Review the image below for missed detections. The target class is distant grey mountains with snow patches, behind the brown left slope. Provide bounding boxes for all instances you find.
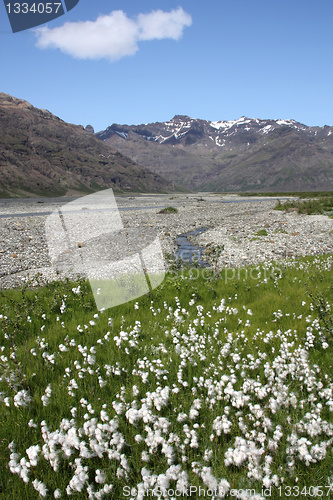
[96,115,333,192]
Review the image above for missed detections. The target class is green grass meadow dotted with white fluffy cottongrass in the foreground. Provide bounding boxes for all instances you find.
[0,256,333,500]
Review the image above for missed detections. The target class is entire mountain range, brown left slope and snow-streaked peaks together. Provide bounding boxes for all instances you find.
[0,93,333,197]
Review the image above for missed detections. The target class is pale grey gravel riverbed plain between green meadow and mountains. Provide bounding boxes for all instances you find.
[0,193,333,288]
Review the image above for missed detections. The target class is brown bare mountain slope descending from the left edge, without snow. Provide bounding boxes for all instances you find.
[0,93,174,197]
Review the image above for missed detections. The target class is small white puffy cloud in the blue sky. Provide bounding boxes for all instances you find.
[35,7,192,61]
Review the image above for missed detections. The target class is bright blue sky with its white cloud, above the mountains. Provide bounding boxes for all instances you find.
[0,0,333,131]
